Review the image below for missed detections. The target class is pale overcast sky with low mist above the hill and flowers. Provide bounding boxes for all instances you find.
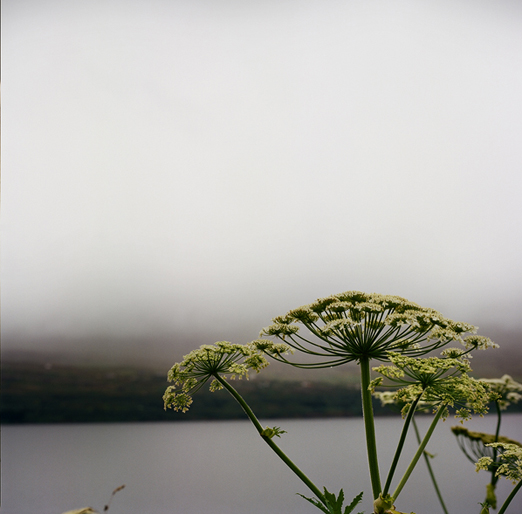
[1,0,522,364]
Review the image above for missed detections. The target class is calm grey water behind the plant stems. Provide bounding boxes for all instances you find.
[1,414,522,514]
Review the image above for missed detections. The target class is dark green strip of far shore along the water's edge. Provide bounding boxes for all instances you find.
[5,361,522,424]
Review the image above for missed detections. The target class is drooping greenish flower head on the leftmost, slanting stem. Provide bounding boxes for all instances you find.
[163,341,268,412]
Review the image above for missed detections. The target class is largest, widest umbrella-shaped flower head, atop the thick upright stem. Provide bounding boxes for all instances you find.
[261,291,495,368]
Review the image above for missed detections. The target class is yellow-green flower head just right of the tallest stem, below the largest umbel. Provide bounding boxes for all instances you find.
[372,352,491,419]
